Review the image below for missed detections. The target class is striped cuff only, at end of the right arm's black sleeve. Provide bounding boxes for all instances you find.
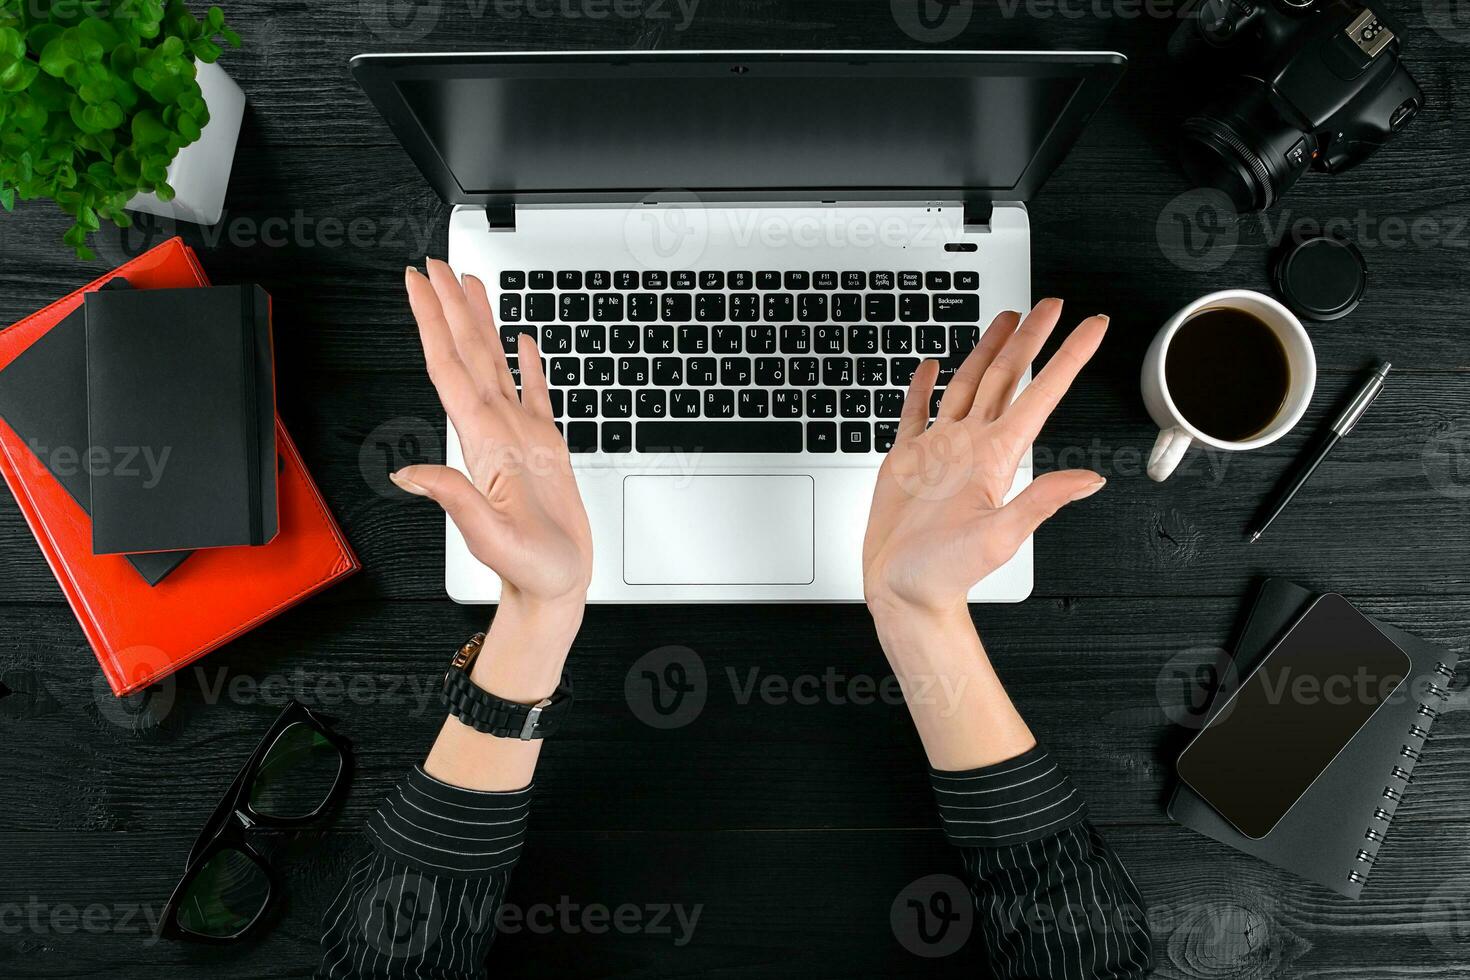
[929,745,1088,848]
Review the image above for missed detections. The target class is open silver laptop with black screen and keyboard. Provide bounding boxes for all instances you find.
[351,50,1125,602]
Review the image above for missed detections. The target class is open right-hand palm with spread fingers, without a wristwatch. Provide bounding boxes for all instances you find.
[863,300,1108,619]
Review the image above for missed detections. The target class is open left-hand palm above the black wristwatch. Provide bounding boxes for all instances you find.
[392,259,592,633]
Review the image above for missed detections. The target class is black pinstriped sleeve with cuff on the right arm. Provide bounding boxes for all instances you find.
[931,746,1154,980]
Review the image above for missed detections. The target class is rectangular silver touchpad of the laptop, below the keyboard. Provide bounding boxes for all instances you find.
[623,475,816,585]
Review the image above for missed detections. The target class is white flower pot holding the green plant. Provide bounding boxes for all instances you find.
[128,62,245,225]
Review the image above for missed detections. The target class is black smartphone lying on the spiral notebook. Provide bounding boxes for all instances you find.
[1177,594,1413,840]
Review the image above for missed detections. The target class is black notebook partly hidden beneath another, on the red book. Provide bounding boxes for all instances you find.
[0,278,190,585]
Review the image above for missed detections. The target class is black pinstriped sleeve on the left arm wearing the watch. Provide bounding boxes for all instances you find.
[316,767,531,980]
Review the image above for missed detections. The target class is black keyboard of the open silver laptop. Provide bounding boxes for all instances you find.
[497,269,980,453]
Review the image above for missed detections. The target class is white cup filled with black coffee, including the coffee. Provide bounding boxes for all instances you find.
[1142,289,1317,482]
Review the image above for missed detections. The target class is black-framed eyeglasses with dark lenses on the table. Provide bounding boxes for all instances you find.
[159,701,351,943]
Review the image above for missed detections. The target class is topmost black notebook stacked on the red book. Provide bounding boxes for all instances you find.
[87,287,276,554]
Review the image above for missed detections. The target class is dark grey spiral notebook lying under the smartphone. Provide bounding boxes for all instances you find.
[1169,579,1457,898]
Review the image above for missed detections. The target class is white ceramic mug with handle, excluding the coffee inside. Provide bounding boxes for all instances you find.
[1144,289,1317,482]
